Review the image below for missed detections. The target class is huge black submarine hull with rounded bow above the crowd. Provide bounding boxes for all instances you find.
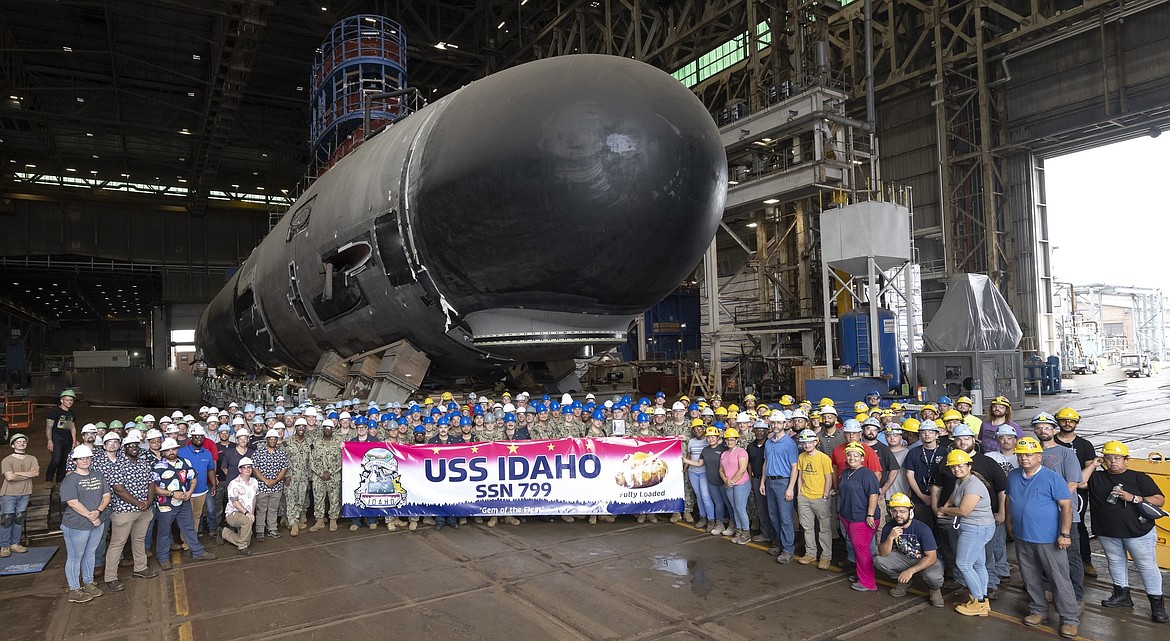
[195,54,728,388]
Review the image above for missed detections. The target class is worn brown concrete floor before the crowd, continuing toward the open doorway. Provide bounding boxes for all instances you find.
[0,370,1170,641]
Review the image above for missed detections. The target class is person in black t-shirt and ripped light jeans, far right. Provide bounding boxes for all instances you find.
[1088,441,1168,623]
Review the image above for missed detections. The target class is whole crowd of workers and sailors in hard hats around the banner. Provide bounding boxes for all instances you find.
[0,390,1166,637]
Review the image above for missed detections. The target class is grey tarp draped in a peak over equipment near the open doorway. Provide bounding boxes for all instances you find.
[923,274,1024,352]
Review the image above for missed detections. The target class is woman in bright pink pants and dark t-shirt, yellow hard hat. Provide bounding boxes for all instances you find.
[837,443,879,592]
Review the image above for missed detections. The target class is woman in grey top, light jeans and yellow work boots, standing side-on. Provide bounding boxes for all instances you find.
[937,449,996,616]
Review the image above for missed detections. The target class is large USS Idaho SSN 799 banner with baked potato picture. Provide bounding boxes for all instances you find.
[342,439,684,517]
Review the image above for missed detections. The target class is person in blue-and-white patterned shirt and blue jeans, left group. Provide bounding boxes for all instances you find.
[151,439,215,570]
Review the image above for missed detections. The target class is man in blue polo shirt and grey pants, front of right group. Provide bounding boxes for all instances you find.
[1005,436,1080,639]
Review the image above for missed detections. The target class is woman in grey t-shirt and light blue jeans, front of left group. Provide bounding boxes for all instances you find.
[61,446,110,604]
